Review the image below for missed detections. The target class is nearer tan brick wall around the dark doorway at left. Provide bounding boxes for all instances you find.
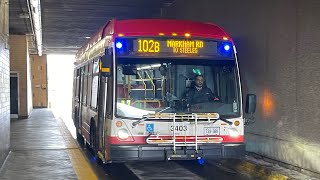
[9,35,32,118]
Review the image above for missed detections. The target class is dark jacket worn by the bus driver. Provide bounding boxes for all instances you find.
[186,87,214,104]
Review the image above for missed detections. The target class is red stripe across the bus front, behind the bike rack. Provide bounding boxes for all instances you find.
[106,135,244,144]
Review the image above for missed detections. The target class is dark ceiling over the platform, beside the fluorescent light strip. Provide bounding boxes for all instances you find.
[9,0,174,53]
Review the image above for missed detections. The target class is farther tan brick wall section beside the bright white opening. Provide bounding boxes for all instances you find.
[31,54,48,107]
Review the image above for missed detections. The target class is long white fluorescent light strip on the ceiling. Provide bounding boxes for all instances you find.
[29,0,42,56]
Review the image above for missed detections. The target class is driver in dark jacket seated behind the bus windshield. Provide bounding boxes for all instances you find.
[186,75,220,105]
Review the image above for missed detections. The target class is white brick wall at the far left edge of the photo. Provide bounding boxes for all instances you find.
[0,0,10,167]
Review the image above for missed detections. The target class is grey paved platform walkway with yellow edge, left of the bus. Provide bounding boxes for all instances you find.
[0,109,97,180]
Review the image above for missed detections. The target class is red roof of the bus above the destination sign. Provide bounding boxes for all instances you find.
[76,19,232,62]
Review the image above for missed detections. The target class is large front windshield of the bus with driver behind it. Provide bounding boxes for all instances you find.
[116,58,240,118]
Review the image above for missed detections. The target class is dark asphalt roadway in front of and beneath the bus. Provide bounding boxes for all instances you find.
[83,149,250,180]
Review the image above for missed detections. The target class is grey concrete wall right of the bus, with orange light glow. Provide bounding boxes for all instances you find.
[163,0,320,173]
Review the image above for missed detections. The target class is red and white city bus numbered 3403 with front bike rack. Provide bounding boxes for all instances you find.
[73,19,256,163]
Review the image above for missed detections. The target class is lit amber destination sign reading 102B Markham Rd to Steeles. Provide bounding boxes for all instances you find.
[132,38,217,56]
